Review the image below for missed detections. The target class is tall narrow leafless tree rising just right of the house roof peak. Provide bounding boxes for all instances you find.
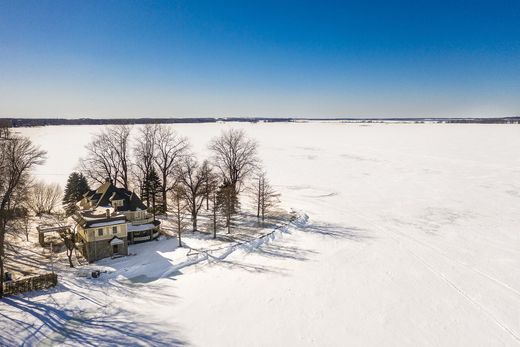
[133,124,158,207]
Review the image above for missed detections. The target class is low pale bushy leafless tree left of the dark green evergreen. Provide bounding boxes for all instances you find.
[29,181,63,216]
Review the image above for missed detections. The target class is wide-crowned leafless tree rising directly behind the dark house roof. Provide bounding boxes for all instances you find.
[80,125,131,189]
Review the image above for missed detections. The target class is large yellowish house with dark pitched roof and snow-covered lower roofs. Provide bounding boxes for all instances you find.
[73,180,160,262]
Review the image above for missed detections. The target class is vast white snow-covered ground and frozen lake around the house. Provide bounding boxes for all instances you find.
[0,123,520,346]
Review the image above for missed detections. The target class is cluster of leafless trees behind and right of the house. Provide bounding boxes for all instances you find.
[77,124,277,239]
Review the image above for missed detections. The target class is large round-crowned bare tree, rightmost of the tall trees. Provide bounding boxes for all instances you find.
[209,129,258,206]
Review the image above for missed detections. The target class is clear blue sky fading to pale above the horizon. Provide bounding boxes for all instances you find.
[0,0,520,117]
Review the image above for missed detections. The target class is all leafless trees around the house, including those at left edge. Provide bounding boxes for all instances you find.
[0,124,279,297]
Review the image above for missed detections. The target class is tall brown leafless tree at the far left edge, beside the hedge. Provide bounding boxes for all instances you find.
[0,134,46,297]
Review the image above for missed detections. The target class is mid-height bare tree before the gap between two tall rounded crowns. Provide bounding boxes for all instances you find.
[179,156,209,231]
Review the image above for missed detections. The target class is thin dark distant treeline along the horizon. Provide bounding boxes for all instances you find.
[0,117,520,128]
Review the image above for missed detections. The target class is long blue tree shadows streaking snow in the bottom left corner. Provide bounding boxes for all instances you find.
[0,297,187,346]
